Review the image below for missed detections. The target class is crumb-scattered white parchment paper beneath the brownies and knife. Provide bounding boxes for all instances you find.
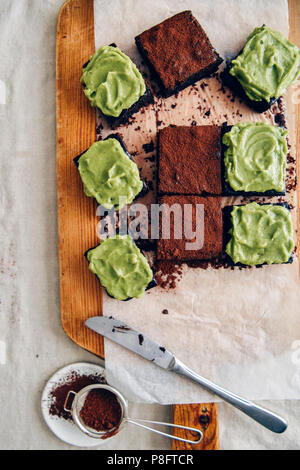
[95,0,300,404]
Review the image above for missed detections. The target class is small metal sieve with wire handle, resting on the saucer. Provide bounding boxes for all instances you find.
[64,384,203,445]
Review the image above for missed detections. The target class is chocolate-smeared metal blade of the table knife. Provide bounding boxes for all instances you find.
[85,317,175,370]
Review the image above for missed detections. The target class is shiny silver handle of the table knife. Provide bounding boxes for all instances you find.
[170,358,287,433]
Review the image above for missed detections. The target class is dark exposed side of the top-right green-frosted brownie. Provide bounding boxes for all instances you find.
[220,57,279,113]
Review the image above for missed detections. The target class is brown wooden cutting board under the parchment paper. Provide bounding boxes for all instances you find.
[56,0,300,450]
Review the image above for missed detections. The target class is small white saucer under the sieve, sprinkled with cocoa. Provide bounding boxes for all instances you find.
[41,362,105,447]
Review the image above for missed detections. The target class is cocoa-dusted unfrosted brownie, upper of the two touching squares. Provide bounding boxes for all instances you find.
[158,125,222,195]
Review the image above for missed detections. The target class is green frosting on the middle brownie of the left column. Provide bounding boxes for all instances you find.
[78,138,143,210]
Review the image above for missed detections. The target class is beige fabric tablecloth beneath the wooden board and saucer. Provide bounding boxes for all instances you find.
[0,0,300,450]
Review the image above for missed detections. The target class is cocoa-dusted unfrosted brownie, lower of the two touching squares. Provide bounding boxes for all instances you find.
[157,196,223,262]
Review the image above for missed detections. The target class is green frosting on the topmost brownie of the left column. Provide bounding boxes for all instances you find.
[81,46,146,117]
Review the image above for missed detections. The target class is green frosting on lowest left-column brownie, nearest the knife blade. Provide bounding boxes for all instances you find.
[87,235,153,300]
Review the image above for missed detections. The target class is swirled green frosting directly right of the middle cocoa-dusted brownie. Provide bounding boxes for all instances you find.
[222,122,288,193]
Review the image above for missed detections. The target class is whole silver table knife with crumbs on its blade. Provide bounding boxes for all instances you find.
[85,317,287,433]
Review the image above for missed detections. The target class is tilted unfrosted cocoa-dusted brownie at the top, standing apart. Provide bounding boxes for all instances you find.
[135,10,223,97]
